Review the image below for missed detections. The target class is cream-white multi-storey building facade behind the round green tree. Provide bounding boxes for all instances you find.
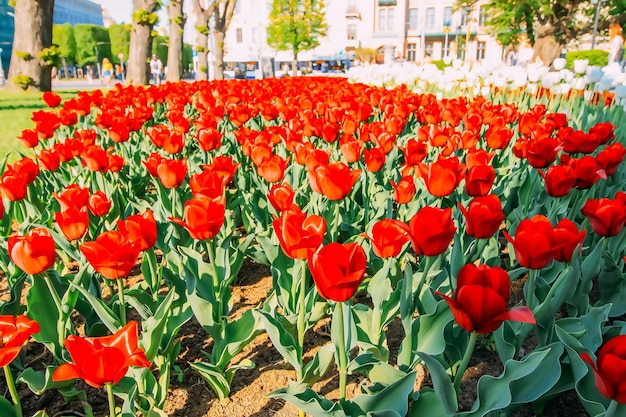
[201,0,503,69]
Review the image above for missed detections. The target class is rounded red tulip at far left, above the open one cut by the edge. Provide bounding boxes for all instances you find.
[9,227,57,275]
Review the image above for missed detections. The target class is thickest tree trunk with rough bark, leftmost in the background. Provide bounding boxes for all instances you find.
[8,0,54,91]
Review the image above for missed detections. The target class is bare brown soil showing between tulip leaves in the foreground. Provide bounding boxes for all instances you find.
[0,261,587,417]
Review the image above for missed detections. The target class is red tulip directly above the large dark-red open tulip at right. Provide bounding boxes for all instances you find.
[459,194,505,239]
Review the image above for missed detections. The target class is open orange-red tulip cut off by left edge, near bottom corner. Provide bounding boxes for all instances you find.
[0,315,39,367]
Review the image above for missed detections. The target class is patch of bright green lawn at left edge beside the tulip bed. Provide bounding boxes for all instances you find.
[0,90,76,161]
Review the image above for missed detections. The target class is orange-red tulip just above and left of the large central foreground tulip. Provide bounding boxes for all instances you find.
[272,209,326,259]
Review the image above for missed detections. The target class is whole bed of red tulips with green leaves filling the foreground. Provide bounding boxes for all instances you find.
[0,78,626,416]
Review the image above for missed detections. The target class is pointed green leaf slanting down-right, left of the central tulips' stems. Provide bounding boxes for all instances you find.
[254,309,302,371]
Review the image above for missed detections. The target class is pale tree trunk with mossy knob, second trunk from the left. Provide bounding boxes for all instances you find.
[127,0,159,85]
